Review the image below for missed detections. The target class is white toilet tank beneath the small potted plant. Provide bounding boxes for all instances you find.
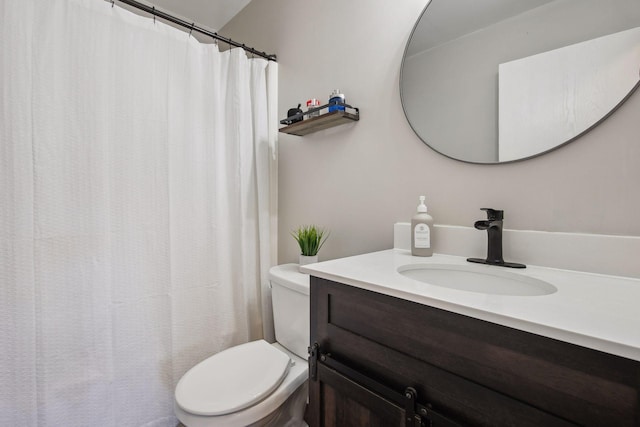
[269,264,310,359]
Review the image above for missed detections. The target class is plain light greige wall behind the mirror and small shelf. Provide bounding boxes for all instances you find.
[220,0,640,263]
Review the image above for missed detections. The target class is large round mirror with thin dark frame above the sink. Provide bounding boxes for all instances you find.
[400,0,640,163]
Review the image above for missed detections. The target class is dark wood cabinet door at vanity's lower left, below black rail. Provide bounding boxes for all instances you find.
[308,363,405,427]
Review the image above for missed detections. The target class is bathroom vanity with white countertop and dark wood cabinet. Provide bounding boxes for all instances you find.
[306,250,640,427]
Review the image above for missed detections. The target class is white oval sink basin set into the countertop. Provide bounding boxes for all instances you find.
[398,264,558,296]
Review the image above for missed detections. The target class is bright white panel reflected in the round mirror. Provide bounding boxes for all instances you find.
[498,27,640,162]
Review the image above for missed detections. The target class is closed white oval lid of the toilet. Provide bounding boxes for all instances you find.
[176,340,291,415]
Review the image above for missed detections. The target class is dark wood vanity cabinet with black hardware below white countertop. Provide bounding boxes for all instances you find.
[308,277,640,427]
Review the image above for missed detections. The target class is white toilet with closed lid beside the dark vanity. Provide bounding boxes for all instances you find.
[174,264,309,427]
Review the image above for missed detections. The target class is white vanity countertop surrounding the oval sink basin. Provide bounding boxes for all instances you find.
[301,249,640,361]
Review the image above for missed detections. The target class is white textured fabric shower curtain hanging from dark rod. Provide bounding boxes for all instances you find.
[0,0,277,427]
